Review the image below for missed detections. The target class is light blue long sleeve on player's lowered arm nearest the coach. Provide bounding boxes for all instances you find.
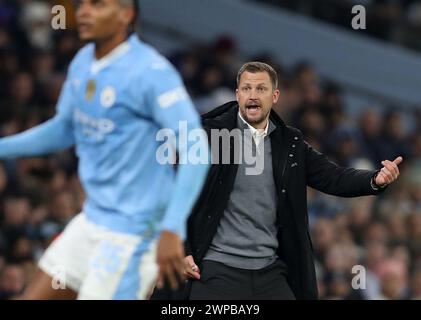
[147,62,209,238]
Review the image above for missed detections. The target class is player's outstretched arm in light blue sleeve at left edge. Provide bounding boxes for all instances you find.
[0,80,74,159]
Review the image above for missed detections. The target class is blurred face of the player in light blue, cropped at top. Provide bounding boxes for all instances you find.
[76,0,133,41]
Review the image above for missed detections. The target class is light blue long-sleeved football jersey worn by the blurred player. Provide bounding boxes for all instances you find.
[0,35,208,238]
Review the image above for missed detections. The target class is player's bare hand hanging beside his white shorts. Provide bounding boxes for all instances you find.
[156,231,185,290]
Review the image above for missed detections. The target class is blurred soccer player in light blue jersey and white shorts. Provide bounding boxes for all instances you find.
[0,0,207,299]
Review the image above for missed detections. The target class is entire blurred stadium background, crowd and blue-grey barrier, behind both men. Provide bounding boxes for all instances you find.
[0,0,421,299]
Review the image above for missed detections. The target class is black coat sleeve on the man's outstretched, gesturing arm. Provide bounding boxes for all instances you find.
[304,142,385,197]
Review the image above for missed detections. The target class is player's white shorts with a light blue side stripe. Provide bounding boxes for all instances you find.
[39,213,158,300]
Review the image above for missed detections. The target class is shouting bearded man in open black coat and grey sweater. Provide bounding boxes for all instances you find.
[181,62,402,299]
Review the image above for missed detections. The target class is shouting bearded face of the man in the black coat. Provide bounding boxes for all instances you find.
[235,71,279,128]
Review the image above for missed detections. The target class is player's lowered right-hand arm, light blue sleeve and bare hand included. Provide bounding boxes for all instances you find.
[145,63,209,288]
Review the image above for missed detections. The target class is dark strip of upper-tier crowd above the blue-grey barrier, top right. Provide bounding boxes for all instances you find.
[258,0,421,50]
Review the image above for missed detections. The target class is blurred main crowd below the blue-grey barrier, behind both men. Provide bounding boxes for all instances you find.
[0,0,421,299]
